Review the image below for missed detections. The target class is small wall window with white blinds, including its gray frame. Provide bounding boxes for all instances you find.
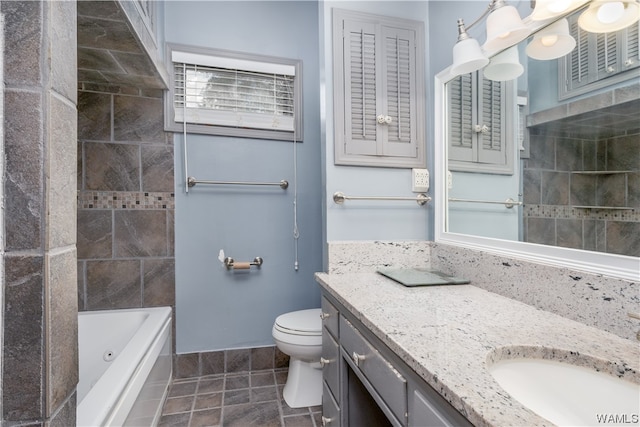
[165,45,302,141]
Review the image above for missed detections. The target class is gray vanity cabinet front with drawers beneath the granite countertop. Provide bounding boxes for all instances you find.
[322,292,471,427]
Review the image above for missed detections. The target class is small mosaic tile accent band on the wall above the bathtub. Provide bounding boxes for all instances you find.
[78,191,175,209]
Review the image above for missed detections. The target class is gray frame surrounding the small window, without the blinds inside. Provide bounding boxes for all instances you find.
[164,43,304,142]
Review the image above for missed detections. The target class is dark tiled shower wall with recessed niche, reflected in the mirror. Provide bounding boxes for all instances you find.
[523,128,640,256]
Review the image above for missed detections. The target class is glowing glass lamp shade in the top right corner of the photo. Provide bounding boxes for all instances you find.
[578,0,640,33]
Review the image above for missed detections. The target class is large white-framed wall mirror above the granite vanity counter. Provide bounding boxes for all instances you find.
[435,5,640,280]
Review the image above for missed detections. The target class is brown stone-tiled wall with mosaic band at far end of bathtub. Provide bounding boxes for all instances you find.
[78,83,175,311]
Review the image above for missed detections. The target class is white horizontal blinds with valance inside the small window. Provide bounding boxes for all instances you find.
[172,52,295,131]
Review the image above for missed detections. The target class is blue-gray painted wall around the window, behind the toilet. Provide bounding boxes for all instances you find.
[165,1,322,353]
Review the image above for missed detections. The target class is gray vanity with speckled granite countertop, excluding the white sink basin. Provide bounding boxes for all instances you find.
[316,273,640,426]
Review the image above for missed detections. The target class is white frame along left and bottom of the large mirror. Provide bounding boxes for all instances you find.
[433,16,640,281]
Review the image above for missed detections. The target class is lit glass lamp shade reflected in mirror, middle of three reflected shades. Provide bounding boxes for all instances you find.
[526,18,576,60]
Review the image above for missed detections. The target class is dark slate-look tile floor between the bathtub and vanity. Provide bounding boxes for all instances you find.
[159,368,322,427]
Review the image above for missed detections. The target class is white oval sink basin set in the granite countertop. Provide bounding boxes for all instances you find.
[489,358,640,426]
